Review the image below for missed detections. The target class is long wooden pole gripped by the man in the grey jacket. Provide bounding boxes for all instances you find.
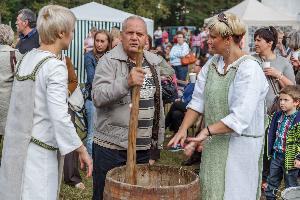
[125,48,143,185]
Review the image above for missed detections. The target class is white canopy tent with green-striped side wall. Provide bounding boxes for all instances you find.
[65,2,154,83]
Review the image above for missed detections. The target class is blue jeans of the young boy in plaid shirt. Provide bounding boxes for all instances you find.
[265,153,299,200]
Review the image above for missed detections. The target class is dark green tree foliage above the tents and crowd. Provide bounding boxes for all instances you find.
[0,0,242,26]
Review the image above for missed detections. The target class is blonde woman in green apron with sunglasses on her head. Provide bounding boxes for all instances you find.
[168,13,268,200]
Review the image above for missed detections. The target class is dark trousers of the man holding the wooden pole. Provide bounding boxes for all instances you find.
[93,144,150,200]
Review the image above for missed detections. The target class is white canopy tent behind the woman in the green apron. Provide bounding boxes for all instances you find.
[204,0,300,52]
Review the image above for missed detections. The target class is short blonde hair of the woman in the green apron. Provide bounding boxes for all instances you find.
[208,12,246,42]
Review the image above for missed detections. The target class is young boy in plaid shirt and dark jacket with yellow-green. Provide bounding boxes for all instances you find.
[265,85,300,200]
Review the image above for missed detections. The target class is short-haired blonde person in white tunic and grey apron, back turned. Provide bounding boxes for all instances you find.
[0,5,92,200]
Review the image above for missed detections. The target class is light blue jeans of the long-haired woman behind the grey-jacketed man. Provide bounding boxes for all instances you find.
[85,99,96,156]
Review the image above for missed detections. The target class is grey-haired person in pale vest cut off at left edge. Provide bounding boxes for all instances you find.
[0,24,21,142]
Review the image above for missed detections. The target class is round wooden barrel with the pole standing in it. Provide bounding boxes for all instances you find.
[103,165,200,200]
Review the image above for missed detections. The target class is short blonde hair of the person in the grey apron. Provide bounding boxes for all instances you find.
[37,5,76,44]
